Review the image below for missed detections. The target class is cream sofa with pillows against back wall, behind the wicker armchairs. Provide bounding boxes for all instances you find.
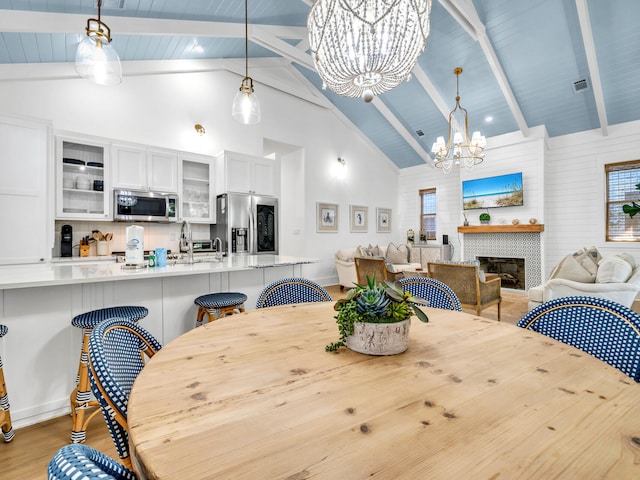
[335,242,422,288]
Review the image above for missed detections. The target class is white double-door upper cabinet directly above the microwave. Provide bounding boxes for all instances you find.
[113,145,178,193]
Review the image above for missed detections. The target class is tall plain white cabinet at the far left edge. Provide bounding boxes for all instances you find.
[0,116,53,265]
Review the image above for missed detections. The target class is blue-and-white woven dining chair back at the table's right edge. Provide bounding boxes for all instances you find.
[517,296,640,382]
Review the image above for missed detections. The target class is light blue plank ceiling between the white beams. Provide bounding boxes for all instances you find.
[0,0,640,168]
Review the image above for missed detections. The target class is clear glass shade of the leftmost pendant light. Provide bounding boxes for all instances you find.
[76,36,122,86]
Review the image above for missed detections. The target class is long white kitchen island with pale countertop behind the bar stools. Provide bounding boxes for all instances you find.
[0,255,318,432]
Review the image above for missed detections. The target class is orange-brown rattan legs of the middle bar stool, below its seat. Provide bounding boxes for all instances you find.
[69,328,100,443]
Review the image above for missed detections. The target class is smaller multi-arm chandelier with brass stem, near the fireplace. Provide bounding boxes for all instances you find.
[431,67,487,173]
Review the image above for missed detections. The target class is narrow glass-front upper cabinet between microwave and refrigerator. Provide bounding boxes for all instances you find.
[179,155,215,223]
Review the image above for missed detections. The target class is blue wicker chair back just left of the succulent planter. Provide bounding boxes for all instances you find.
[256,278,331,308]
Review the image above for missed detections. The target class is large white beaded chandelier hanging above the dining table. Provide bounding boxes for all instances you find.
[307,0,431,101]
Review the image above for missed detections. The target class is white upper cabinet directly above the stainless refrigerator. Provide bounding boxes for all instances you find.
[216,152,279,197]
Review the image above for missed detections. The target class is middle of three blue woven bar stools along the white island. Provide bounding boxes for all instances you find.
[69,306,149,443]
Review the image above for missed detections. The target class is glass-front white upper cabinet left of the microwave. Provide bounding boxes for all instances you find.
[56,136,111,220]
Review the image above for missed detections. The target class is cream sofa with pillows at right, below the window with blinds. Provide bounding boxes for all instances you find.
[528,247,640,310]
